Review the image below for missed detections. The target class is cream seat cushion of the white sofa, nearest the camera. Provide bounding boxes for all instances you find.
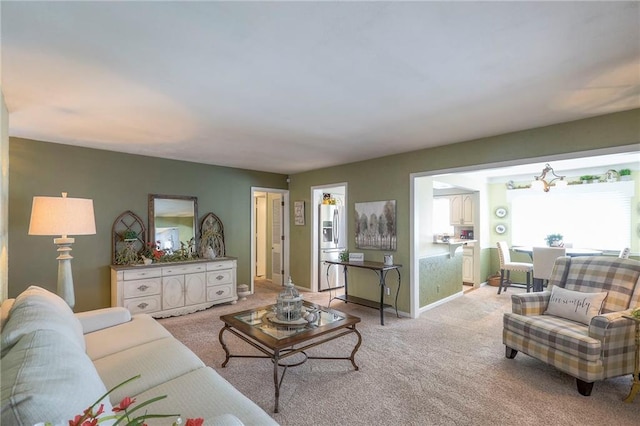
[132,367,278,426]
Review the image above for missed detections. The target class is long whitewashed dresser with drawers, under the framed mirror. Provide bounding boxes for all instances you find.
[111,257,238,318]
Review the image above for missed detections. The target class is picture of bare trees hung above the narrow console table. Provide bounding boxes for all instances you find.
[354,200,398,250]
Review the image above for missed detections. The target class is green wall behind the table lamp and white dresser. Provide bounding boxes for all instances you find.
[8,138,287,312]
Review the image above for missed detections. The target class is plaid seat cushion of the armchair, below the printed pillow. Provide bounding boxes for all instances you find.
[503,312,602,362]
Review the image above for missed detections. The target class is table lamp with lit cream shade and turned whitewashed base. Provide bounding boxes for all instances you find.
[29,192,96,309]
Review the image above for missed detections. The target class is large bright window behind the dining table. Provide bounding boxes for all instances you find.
[508,182,633,251]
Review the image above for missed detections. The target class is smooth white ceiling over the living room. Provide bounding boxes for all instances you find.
[0,1,640,174]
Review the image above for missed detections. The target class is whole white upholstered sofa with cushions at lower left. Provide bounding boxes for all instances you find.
[1,286,277,426]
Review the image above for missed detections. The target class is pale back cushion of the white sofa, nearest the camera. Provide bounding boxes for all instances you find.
[1,329,111,425]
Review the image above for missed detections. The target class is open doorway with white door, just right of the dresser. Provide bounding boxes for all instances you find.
[250,188,289,292]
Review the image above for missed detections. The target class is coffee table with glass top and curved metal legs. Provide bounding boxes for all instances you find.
[218,301,362,413]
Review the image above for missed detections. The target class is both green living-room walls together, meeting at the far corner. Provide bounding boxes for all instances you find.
[8,109,640,312]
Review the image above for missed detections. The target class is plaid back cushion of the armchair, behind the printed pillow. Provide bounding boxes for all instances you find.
[559,256,640,314]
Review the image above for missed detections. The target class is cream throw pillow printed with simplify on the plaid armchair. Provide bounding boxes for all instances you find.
[544,285,608,325]
